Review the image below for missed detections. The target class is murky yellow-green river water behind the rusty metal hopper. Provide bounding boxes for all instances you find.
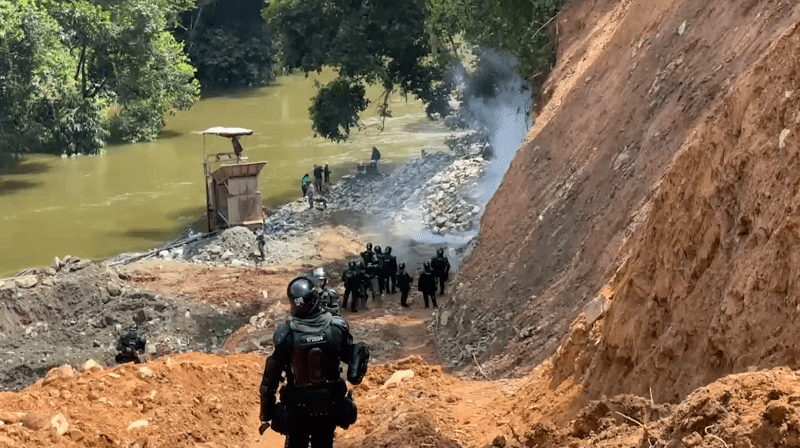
[0,73,447,278]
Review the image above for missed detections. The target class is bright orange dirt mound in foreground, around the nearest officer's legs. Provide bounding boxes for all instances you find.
[0,353,508,448]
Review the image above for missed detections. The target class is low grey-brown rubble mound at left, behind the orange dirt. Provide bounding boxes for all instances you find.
[0,264,251,389]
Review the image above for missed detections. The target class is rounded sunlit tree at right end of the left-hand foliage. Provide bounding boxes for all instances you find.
[46,0,200,142]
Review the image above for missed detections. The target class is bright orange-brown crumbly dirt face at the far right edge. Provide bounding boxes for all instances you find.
[556,8,800,401]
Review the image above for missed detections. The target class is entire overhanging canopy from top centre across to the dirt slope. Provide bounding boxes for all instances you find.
[264,0,562,141]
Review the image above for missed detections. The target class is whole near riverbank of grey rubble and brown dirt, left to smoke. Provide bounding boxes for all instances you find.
[0,152,483,389]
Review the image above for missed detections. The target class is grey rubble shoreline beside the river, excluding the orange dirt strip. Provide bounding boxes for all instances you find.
[0,152,486,389]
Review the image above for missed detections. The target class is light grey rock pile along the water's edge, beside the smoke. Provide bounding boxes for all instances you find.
[150,152,487,266]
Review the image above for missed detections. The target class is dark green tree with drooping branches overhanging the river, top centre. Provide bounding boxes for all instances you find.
[263,0,451,141]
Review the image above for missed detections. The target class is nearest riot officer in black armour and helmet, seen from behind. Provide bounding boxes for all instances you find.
[259,277,369,448]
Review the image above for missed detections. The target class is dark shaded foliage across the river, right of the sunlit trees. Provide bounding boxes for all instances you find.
[174,0,273,88]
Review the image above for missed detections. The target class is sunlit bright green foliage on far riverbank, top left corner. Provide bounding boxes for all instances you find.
[0,0,199,168]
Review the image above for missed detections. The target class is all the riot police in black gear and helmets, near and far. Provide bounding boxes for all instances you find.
[117,243,450,448]
